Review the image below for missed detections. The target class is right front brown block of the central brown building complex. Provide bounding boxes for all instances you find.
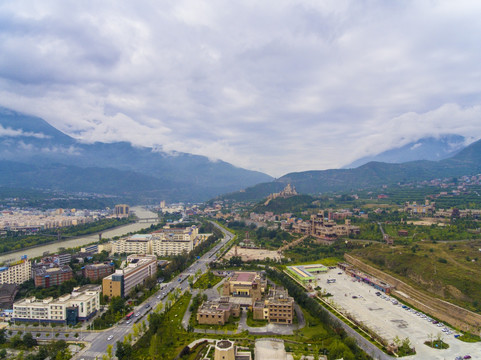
[252,289,294,324]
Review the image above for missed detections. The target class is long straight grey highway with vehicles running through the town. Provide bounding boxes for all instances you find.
[73,222,234,360]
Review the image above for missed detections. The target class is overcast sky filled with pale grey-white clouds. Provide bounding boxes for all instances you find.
[0,0,481,177]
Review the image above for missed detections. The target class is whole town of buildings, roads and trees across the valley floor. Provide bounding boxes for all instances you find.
[0,178,481,359]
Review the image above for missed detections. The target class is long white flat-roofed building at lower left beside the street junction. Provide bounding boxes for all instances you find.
[12,285,102,325]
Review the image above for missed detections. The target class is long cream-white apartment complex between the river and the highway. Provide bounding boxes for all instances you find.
[112,225,199,256]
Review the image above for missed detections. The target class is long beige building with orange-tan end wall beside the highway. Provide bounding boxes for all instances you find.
[102,255,157,297]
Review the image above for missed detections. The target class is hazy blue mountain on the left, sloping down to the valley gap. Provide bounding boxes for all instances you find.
[0,108,272,203]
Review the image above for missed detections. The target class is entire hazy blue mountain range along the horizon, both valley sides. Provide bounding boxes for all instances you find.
[0,108,481,203]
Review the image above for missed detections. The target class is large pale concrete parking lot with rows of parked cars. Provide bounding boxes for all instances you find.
[315,269,481,359]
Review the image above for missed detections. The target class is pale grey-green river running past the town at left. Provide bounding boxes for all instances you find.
[0,206,157,263]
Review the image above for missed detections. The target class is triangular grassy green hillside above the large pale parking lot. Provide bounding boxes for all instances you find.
[350,240,481,313]
